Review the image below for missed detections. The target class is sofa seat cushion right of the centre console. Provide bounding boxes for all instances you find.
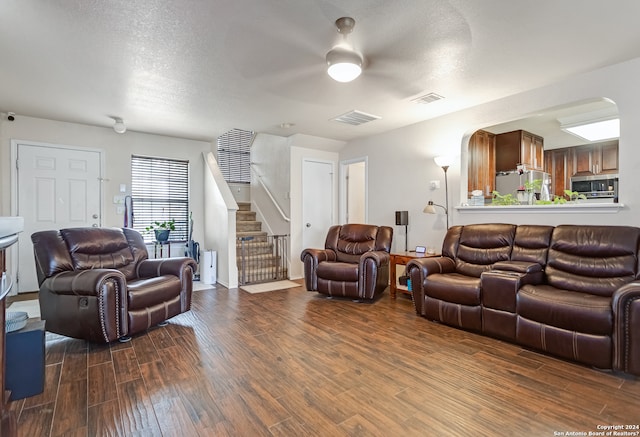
[516,285,613,335]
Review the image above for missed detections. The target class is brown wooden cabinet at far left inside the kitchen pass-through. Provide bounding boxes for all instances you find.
[467,130,496,198]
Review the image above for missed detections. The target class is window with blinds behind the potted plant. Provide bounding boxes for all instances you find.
[131,155,189,242]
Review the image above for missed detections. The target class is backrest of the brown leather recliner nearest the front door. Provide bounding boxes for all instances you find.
[31,227,148,284]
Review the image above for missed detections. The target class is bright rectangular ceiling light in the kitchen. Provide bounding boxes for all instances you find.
[558,109,620,141]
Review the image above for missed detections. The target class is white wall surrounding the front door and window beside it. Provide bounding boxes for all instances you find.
[0,114,211,272]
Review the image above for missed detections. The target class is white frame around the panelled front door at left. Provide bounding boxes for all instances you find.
[8,139,109,296]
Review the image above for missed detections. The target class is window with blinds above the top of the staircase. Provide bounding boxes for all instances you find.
[218,129,255,184]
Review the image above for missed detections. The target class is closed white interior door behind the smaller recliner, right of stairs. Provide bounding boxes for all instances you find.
[302,160,334,248]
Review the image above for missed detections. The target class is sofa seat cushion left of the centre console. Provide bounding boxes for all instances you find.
[425,273,480,306]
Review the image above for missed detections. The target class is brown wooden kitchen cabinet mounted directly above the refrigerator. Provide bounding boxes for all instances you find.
[495,130,544,171]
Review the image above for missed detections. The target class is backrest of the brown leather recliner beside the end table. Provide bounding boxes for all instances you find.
[325,223,393,263]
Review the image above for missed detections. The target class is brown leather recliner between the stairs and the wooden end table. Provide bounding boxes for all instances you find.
[300,224,393,300]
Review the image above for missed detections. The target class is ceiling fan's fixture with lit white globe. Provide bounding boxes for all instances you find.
[326,17,363,82]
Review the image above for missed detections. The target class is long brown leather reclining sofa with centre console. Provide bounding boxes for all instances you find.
[407,224,640,375]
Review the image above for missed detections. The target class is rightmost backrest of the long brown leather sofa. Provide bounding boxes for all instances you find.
[546,225,640,296]
